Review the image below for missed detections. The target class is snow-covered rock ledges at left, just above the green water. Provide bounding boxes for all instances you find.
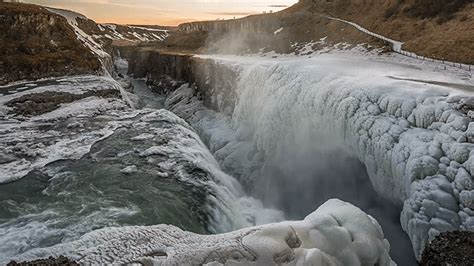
[0,76,127,183]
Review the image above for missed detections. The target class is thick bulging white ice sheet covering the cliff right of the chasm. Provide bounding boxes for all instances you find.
[167,55,474,257]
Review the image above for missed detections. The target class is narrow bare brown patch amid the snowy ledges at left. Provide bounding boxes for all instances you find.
[5,89,120,116]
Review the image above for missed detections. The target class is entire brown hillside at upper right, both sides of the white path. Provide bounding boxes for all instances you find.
[147,0,474,64]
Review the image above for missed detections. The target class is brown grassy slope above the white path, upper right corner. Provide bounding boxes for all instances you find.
[300,0,474,64]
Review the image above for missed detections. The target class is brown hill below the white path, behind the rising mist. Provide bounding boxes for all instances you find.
[120,1,383,56]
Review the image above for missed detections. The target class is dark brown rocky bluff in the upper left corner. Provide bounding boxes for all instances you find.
[0,3,101,85]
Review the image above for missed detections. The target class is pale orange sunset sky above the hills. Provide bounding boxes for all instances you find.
[22,0,298,26]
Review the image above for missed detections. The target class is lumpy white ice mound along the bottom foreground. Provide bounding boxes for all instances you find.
[5,200,394,265]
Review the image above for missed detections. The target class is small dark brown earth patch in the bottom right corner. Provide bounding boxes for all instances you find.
[420,231,474,266]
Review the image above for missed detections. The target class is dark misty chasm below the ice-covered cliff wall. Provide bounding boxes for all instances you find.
[255,145,417,265]
